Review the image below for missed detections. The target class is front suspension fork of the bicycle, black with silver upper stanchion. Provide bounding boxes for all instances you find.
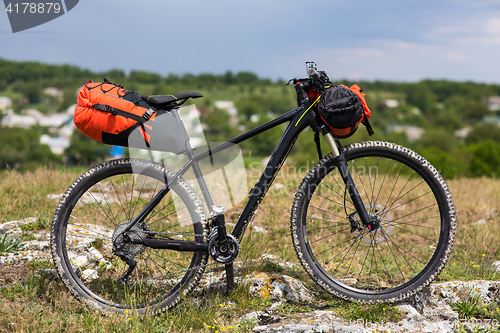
[323,131,378,232]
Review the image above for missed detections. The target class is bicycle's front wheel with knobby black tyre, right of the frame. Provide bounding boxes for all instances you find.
[291,142,456,303]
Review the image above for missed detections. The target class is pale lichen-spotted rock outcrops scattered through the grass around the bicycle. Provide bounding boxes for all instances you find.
[0,218,500,333]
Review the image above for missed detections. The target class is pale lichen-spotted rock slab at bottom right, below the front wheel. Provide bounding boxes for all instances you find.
[242,275,500,333]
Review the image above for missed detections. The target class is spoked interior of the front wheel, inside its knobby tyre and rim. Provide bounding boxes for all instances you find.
[298,148,456,295]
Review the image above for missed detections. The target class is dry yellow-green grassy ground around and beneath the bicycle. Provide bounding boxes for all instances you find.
[0,164,500,332]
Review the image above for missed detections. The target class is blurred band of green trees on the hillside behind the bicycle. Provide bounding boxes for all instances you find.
[0,59,500,178]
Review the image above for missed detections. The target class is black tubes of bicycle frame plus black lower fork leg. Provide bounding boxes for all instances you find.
[123,98,368,251]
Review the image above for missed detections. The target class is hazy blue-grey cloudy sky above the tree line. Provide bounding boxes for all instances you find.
[0,0,500,83]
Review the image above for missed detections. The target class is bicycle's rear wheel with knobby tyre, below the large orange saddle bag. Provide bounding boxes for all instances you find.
[51,159,208,314]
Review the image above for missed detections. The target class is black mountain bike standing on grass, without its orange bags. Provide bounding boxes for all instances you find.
[51,63,456,314]
